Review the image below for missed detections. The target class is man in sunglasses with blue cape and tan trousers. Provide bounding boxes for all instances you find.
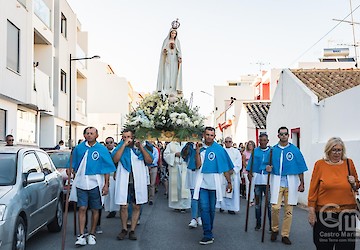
[266,127,308,245]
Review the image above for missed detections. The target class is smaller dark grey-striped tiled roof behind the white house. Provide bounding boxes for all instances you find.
[243,102,271,129]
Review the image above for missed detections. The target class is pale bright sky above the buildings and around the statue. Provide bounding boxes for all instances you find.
[67,0,360,114]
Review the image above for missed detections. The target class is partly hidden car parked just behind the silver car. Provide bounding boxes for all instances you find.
[46,150,74,195]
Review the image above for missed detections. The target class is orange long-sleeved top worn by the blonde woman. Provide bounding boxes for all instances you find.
[308,159,359,211]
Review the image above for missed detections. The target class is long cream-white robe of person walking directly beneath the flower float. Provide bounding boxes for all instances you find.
[164,142,191,209]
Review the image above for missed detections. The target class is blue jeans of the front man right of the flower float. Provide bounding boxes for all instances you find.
[199,188,216,239]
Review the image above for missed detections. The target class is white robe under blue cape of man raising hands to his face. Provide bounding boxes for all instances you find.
[115,150,150,205]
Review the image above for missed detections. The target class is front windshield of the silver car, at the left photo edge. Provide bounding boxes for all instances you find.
[0,154,16,186]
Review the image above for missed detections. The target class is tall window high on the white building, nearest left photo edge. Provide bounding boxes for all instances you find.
[6,20,20,73]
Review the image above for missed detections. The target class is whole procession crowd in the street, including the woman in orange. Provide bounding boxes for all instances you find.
[62,127,359,249]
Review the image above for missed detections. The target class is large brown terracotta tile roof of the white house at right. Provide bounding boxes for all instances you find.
[291,69,360,101]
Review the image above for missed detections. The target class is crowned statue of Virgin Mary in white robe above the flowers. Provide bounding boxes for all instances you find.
[156,20,183,96]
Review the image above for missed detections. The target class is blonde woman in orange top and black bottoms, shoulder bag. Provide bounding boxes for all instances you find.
[308,137,359,250]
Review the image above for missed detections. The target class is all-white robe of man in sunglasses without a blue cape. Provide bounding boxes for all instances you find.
[216,147,242,212]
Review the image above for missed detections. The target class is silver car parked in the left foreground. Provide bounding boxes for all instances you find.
[0,146,63,250]
